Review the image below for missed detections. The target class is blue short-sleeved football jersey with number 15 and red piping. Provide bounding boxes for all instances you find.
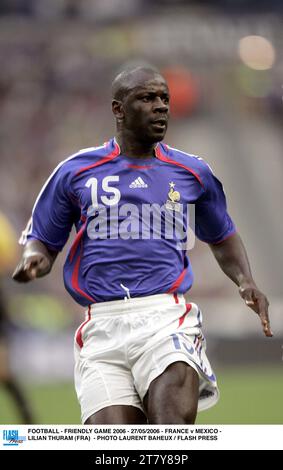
[23,139,236,306]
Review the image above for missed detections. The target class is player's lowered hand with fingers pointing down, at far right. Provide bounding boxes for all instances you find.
[239,285,273,337]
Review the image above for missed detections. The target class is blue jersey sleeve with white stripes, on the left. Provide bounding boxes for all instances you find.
[20,166,79,251]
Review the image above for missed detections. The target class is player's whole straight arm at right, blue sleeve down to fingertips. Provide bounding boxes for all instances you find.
[195,162,272,336]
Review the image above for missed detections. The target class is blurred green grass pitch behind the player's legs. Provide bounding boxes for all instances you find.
[0,365,283,424]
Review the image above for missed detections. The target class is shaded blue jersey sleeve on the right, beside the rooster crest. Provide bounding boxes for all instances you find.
[195,163,236,243]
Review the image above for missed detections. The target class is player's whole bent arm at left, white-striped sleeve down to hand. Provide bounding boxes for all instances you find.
[13,165,78,282]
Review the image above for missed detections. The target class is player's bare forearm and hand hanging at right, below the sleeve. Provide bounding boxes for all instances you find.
[209,233,273,337]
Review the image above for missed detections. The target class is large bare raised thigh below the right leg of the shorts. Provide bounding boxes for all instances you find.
[144,361,199,424]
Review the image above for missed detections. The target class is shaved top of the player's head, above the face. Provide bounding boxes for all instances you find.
[112,66,166,101]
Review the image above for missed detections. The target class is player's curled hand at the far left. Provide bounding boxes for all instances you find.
[12,252,51,282]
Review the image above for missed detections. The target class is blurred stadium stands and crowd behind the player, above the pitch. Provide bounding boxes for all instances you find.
[0,0,283,386]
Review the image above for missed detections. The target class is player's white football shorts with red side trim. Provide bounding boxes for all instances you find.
[74,294,219,423]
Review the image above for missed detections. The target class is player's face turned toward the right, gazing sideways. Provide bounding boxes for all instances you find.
[123,75,169,143]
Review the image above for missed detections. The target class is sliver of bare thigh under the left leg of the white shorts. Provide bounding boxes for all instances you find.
[84,405,147,424]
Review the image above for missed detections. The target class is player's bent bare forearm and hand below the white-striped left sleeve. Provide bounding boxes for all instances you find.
[12,240,58,282]
